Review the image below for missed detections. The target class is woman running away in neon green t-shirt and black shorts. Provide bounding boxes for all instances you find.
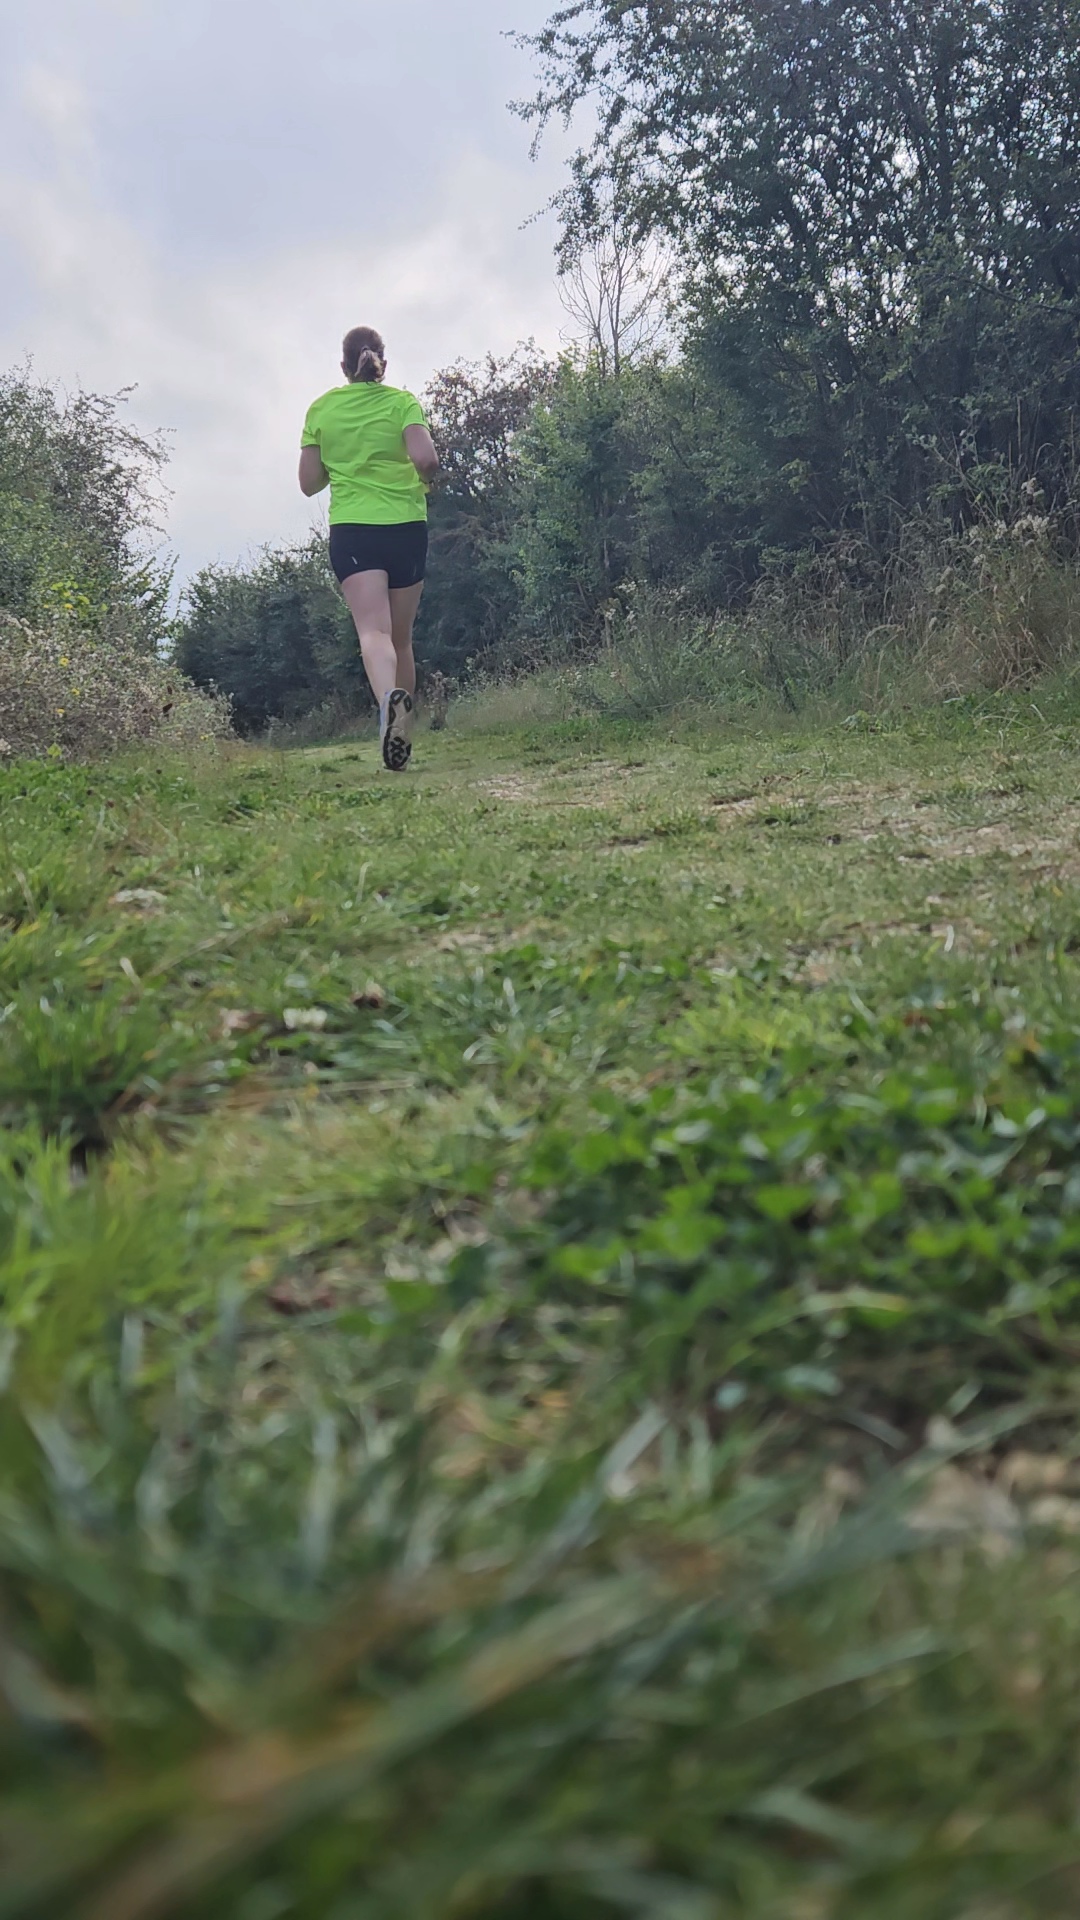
[300,326,438,774]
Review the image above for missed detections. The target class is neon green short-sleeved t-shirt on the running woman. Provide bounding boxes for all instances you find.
[300,380,427,526]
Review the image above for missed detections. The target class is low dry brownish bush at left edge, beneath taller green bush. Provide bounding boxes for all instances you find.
[0,612,231,758]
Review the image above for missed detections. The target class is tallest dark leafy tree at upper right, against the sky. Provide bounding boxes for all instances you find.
[521,0,1080,547]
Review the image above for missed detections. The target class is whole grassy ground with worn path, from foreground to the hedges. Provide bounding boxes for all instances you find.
[0,695,1080,1920]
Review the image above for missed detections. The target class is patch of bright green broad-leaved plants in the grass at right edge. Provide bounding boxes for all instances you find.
[507,1021,1080,1413]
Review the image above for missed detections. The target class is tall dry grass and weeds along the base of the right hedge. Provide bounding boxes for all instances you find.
[468,501,1080,726]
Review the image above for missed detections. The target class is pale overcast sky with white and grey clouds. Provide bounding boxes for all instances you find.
[0,0,563,574]
